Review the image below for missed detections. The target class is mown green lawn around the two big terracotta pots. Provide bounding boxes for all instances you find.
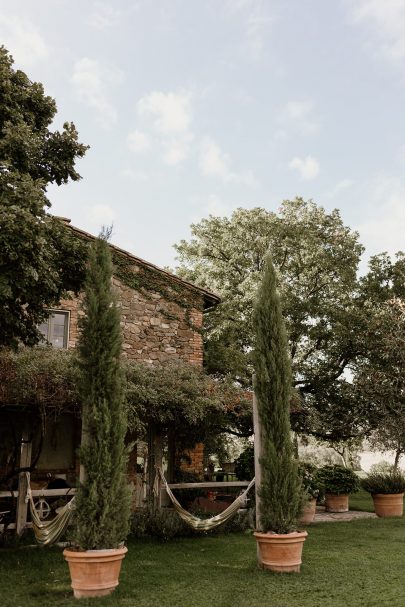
[0,518,405,607]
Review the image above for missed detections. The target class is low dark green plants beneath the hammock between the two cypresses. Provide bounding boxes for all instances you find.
[130,508,254,541]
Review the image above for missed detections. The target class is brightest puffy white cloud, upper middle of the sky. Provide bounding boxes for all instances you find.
[137,91,192,135]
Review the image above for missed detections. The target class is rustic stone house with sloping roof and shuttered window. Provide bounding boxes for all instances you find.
[0,219,219,528]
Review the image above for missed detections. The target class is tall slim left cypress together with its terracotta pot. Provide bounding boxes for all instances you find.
[63,237,130,598]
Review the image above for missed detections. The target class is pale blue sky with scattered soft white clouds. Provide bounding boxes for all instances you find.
[0,0,405,267]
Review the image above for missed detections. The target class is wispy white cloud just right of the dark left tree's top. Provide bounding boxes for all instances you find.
[71,57,123,128]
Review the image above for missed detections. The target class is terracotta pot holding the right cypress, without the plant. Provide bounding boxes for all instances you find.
[255,531,308,573]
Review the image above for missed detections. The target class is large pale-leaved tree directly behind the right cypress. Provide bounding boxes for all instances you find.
[175,198,364,440]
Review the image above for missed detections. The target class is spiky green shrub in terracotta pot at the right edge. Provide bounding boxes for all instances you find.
[361,469,405,516]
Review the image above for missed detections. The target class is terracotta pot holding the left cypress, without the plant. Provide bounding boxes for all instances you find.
[63,547,128,599]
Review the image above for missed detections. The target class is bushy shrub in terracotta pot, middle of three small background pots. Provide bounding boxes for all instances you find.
[318,464,360,512]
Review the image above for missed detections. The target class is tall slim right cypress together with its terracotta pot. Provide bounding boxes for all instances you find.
[254,257,307,573]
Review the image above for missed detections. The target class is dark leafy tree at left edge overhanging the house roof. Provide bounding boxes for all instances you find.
[0,47,87,347]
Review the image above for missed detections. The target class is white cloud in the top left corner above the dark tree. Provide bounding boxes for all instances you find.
[0,14,49,67]
